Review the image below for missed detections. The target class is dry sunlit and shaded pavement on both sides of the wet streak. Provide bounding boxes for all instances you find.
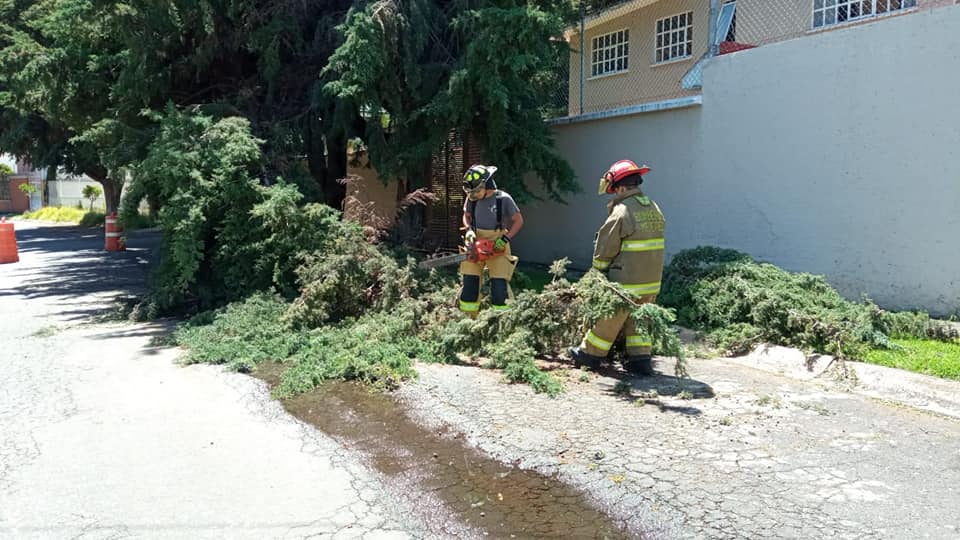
[7,223,960,540]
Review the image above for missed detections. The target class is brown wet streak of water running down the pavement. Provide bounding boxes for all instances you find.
[255,364,635,539]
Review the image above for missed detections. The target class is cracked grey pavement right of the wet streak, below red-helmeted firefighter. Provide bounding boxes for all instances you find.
[399,359,960,539]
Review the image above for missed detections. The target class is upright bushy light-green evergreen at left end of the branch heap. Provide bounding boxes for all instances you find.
[122,106,271,313]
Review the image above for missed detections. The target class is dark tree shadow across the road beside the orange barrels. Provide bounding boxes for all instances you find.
[0,226,160,320]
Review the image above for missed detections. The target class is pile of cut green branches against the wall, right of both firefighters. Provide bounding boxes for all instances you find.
[659,247,953,359]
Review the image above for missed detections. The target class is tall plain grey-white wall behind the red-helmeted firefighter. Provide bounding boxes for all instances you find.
[515,6,960,314]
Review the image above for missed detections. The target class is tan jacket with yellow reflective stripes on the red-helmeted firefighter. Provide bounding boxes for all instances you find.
[593,189,665,296]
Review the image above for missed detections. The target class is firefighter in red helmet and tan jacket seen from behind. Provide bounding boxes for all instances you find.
[570,160,665,375]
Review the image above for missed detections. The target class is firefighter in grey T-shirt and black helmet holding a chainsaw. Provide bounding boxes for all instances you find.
[460,165,523,317]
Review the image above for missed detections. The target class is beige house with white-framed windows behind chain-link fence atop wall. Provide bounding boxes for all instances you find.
[548,0,944,118]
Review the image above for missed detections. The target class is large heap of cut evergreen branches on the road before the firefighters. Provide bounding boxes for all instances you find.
[178,185,685,396]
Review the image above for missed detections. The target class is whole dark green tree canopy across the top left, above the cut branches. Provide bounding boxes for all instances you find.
[0,0,575,209]
